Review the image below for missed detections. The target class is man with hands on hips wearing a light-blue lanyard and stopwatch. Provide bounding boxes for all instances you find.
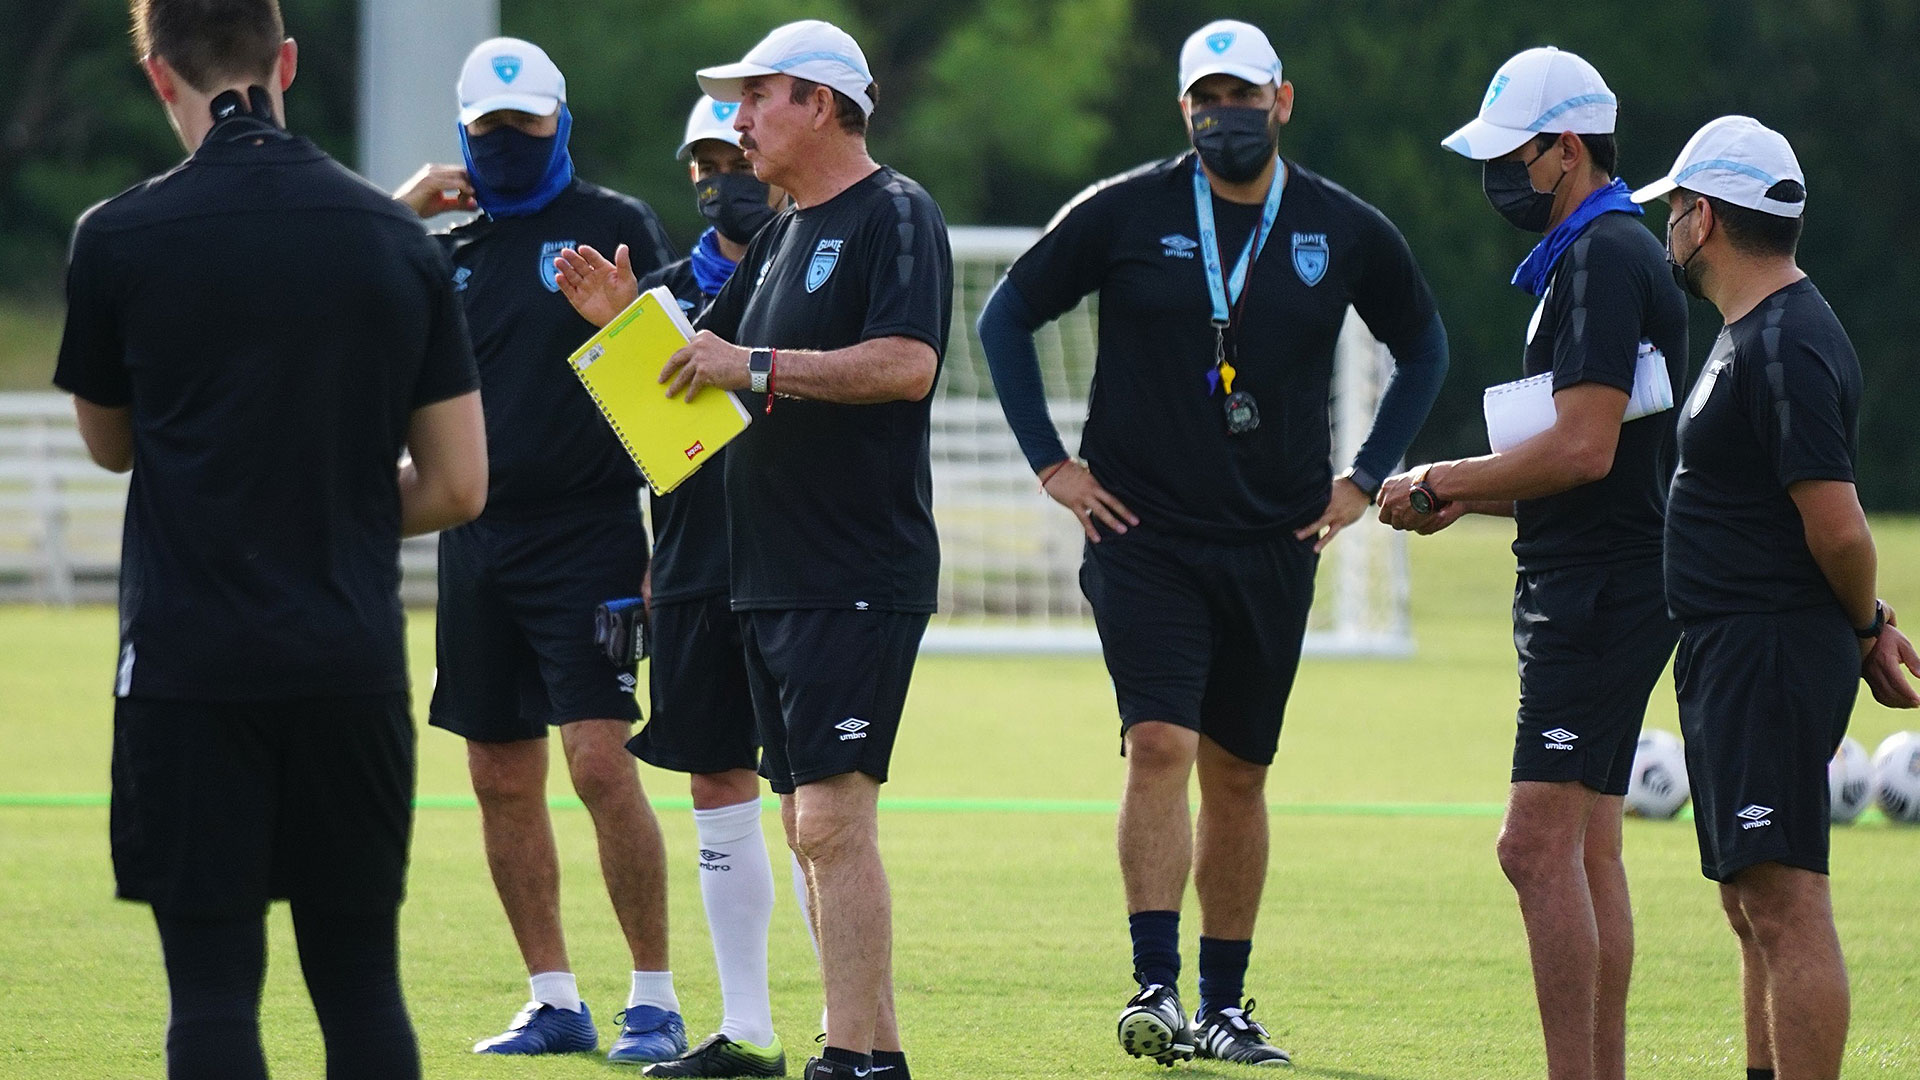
[979,19,1448,1065]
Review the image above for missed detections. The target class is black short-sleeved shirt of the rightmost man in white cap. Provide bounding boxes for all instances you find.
[1667,279,1860,621]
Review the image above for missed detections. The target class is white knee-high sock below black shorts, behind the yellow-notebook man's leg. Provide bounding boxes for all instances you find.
[693,799,774,1045]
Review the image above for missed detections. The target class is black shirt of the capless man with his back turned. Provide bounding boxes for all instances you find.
[54,119,476,700]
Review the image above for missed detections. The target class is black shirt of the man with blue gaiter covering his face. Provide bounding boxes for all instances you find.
[440,181,668,521]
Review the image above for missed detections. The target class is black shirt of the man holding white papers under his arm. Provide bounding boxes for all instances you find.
[1513,213,1688,573]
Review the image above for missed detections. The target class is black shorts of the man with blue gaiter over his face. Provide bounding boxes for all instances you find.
[428,505,647,742]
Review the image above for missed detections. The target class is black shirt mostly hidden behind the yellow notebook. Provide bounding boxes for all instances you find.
[639,259,728,603]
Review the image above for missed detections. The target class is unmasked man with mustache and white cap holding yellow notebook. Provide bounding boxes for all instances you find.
[561,21,952,1080]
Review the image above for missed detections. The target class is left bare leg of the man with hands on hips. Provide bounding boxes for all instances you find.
[1117,721,1200,913]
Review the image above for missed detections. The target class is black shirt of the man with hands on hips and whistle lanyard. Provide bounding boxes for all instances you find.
[1008,154,1434,540]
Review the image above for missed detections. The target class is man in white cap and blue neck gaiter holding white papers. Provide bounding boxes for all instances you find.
[1380,46,1688,1080]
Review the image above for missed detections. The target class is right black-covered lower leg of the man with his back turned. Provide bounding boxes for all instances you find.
[294,903,420,1080]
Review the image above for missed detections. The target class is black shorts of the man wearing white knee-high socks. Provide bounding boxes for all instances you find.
[626,594,760,773]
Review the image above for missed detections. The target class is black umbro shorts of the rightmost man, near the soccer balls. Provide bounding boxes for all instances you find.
[1674,605,1860,882]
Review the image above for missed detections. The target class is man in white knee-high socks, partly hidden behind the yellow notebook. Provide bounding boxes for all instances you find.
[614,94,791,1076]
